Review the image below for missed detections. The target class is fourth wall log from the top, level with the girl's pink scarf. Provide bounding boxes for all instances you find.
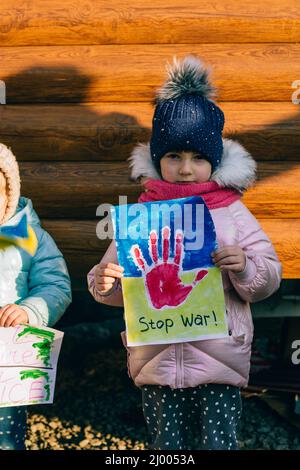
[20,162,300,219]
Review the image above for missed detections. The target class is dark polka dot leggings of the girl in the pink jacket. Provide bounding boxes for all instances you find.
[142,384,242,450]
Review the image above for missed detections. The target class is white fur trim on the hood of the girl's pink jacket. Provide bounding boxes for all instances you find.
[128,139,256,191]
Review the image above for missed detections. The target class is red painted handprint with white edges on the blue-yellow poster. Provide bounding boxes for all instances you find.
[130,227,208,309]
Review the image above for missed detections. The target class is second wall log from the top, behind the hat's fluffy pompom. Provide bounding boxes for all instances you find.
[0,43,300,104]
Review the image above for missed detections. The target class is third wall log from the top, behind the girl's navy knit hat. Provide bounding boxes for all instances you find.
[0,102,300,161]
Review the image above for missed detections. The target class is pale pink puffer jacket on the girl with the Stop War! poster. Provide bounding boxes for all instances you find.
[88,139,282,388]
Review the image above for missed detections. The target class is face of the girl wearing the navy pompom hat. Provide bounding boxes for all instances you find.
[160,152,211,184]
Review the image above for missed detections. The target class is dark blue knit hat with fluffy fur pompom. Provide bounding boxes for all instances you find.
[150,56,224,172]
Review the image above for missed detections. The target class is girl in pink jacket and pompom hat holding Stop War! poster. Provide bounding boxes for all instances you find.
[88,56,281,450]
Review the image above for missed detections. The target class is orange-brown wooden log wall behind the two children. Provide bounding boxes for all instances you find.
[0,0,300,289]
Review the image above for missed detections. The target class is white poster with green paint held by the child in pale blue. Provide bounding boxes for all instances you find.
[0,325,63,407]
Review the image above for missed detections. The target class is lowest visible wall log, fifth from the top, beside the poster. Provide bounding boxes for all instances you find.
[42,219,300,280]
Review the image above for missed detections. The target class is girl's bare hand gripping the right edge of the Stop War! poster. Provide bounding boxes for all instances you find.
[211,245,246,273]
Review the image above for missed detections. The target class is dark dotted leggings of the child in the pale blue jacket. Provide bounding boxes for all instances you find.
[0,406,27,450]
